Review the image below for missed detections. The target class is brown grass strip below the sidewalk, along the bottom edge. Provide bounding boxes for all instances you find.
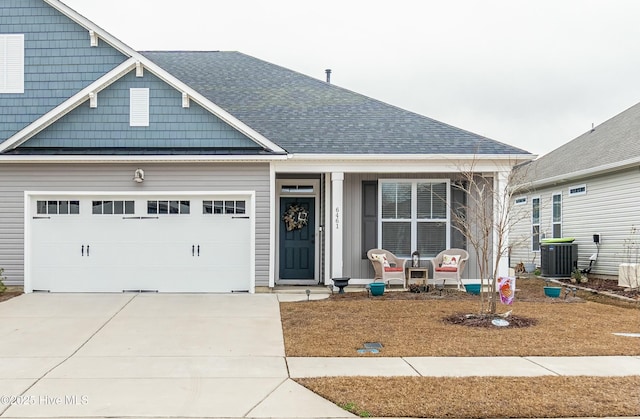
[296,376,640,418]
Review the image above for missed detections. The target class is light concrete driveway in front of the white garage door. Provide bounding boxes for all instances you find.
[0,294,349,418]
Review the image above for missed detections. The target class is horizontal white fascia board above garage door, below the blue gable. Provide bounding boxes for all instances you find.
[0,154,287,164]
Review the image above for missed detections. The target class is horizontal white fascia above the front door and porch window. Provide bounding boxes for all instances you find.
[274,154,533,173]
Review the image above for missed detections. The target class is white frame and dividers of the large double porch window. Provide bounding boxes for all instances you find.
[378,179,451,257]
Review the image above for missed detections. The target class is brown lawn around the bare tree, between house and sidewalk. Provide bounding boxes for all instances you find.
[280,280,640,356]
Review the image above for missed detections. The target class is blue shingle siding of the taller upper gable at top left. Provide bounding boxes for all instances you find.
[0,0,127,142]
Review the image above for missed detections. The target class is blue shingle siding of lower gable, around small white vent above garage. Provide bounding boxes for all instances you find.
[19,70,260,154]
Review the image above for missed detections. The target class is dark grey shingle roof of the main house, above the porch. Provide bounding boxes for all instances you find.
[142,51,529,155]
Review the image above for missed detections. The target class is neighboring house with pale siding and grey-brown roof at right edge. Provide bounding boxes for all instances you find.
[510,104,640,275]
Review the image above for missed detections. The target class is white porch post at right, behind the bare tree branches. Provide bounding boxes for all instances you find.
[493,171,510,276]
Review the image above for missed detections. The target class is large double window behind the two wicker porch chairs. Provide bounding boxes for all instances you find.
[379,180,450,257]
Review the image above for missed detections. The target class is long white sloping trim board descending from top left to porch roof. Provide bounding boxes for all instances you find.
[42,0,286,153]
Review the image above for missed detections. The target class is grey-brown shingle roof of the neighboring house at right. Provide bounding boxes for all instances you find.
[526,103,640,181]
